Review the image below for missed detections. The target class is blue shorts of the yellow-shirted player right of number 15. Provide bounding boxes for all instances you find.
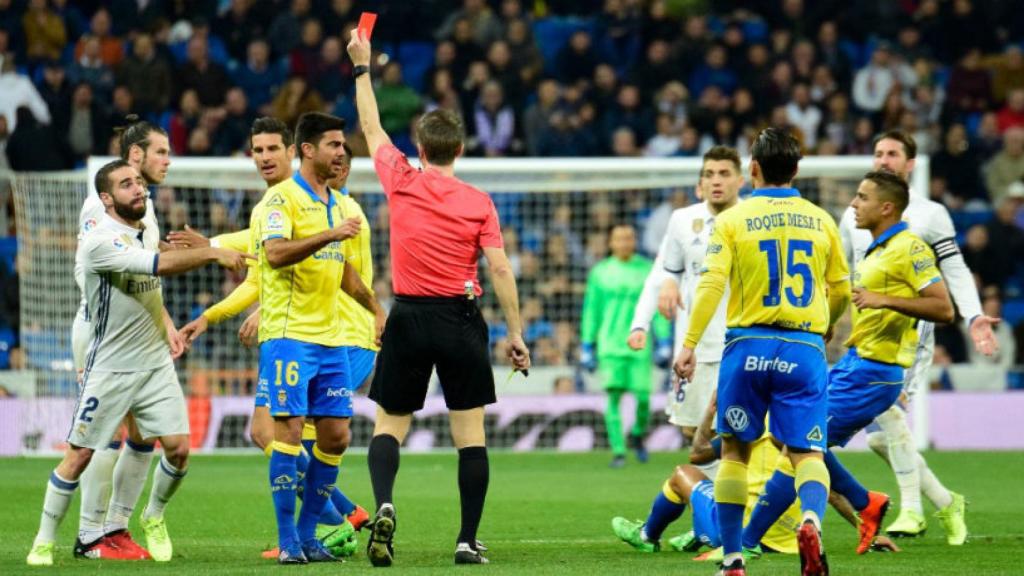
[828,348,903,446]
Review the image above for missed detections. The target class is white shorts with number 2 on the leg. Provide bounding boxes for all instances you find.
[68,363,188,450]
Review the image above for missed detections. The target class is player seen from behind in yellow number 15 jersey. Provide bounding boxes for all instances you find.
[675,128,850,576]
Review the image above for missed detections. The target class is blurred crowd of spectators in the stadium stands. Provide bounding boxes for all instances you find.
[0,0,1024,385]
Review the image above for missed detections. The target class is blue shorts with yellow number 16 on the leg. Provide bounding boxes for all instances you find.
[257,338,352,418]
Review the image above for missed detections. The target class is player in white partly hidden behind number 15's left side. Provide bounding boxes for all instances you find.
[629,147,743,453]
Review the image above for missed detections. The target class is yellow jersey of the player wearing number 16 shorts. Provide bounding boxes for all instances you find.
[256,172,345,346]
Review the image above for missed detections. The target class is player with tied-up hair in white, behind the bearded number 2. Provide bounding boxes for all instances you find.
[72,117,185,560]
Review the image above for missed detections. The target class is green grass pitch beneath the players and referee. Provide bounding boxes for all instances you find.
[0,452,1024,576]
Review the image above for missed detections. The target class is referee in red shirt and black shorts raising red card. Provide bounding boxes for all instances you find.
[348,29,529,566]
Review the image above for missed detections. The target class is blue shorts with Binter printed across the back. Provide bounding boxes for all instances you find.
[718,326,828,452]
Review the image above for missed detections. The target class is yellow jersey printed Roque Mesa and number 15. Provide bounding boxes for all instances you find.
[686,188,850,347]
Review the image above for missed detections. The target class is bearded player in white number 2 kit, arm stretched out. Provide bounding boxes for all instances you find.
[27,160,246,566]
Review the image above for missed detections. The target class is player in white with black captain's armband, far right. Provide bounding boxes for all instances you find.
[840,130,998,545]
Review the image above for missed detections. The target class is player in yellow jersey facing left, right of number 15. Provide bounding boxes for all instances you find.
[743,172,953,553]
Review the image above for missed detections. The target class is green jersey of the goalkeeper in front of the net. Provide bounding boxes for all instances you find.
[580,255,670,361]
